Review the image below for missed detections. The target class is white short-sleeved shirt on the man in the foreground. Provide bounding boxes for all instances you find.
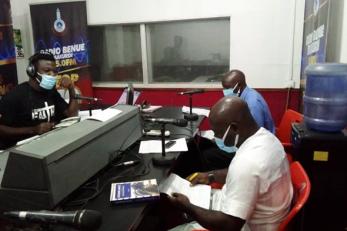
[213,128,293,231]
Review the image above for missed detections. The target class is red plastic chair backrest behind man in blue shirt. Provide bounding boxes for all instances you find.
[276,109,303,143]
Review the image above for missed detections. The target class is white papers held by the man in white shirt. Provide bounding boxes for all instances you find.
[159,173,211,209]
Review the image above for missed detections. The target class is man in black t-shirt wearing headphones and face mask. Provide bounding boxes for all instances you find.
[0,52,78,149]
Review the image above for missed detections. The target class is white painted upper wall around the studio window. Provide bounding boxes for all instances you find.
[11,0,304,88]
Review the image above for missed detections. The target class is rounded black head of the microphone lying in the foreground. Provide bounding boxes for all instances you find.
[77,210,102,231]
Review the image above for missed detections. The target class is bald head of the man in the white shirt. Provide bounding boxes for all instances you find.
[209,96,259,147]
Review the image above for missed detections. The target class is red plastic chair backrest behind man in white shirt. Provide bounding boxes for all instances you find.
[278,161,311,231]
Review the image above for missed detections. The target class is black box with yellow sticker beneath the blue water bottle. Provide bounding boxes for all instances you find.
[292,123,347,231]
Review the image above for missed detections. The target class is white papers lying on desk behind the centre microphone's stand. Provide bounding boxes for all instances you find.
[139,138,188,154]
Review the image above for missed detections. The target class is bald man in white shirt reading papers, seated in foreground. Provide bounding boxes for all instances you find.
[169,97,293,231]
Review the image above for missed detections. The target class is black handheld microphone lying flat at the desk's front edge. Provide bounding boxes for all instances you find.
[3,209,102,231]
